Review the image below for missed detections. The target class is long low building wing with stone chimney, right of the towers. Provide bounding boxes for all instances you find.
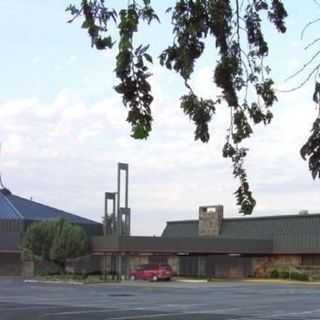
[92,205,320,278]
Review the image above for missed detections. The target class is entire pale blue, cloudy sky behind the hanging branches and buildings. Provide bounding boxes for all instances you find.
[0,0,320,235]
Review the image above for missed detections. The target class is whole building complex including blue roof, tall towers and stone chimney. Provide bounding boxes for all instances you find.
[0,163,320,278]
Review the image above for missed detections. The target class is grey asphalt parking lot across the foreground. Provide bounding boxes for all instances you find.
[0,279,320,320]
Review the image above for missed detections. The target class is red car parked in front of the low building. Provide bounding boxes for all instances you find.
[130,264,174,281]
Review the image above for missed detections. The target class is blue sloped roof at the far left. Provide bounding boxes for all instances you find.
[0,189,99,224]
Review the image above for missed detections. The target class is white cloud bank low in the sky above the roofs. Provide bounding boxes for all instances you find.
[0,65,320,234]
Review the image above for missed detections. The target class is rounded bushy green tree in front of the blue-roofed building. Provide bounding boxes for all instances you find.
[22,219,89,267]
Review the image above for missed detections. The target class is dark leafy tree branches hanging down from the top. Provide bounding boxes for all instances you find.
[67,0,320,215]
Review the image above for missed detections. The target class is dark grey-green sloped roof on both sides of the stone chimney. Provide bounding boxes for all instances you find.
[162,214,320,253]
